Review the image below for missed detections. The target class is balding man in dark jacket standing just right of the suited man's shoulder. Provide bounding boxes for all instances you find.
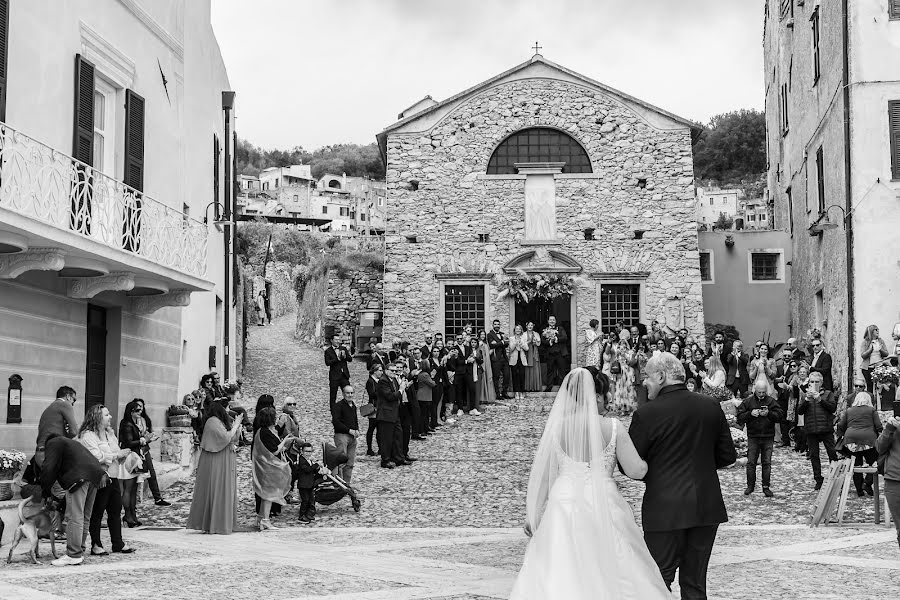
[737,381,784,498]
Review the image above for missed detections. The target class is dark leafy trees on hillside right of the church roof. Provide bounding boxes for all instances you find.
[694,109,766,184]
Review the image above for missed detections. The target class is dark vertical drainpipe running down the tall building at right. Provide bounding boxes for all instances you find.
[841,0,856,390]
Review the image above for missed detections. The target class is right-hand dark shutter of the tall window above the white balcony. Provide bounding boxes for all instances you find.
[122,90,144,253]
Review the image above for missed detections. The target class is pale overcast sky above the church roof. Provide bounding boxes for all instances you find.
[212,0,764,150]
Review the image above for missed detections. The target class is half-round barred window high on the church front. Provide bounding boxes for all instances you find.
[487,127,592,175]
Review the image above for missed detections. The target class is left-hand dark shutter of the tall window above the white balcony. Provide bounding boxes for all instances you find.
[69,54,94,235]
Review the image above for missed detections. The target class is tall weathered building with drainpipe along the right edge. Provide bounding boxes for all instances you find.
[764,0,900,389]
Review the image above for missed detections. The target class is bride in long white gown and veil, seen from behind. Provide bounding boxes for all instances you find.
[510,369,671,600]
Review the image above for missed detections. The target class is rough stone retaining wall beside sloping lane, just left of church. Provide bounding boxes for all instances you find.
[296,269,384,344]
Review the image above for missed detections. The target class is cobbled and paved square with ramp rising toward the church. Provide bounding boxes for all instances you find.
[0,315,900,600]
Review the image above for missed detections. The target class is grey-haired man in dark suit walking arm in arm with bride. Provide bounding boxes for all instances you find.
[629,352,737,598]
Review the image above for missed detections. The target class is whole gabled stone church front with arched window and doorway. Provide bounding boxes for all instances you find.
[378,55,704,365]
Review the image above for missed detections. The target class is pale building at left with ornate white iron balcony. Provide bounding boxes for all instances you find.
[0,0,234,452]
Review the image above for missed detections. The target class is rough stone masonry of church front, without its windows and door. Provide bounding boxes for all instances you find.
[384,79,704,360]
